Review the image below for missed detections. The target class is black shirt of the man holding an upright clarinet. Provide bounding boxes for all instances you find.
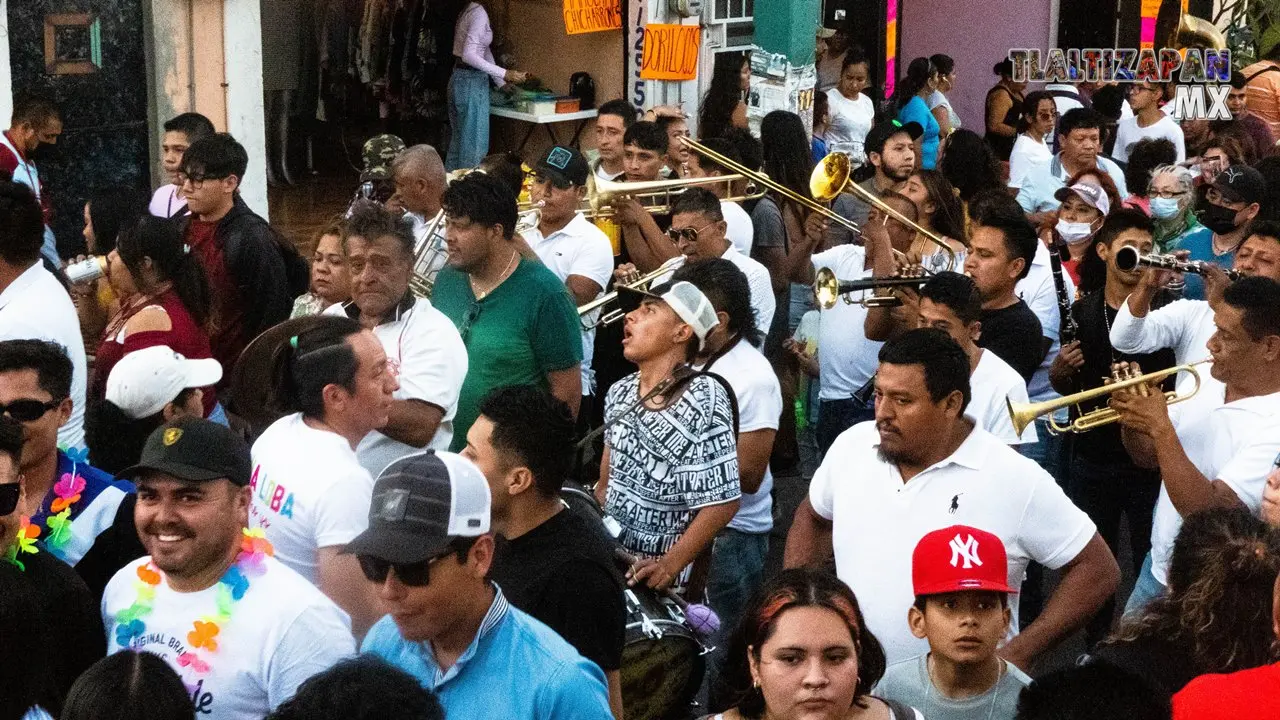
[1071,290,1174,468]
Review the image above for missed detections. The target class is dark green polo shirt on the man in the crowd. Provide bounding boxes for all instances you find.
[431,259,582,452]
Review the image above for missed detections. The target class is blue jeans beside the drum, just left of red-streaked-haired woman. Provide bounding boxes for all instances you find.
[707,528,769,697]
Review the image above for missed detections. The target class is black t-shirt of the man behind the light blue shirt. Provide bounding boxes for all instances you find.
[489,510,627,673]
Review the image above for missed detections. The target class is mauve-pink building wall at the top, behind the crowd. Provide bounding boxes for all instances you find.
[899,0,1057,135]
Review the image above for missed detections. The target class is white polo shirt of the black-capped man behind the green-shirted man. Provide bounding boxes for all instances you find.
[525,213,613,395]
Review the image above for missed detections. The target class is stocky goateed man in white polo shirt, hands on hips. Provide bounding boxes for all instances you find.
[783,328,1120,670]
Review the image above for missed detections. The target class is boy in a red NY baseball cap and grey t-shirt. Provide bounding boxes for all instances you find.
[876,525,1032,720]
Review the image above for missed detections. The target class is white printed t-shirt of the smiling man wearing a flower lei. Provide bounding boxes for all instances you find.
[102,557,356,720]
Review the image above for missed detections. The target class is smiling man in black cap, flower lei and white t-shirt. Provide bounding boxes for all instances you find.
[102,418,356,720]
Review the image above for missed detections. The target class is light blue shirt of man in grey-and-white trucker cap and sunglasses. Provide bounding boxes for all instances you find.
[360,585,613,720]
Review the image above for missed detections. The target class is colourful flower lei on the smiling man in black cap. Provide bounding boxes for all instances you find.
[115,528,275,675]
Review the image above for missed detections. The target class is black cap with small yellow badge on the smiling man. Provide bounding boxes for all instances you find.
[119,418,252,487]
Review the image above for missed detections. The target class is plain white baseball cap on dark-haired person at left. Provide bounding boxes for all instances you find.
[106,345,223,420]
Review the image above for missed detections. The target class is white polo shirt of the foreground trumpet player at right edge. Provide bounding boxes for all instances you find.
[1151,386,1280,585]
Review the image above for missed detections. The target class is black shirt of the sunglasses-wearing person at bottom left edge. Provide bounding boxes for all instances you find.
[0,550,106,715]
